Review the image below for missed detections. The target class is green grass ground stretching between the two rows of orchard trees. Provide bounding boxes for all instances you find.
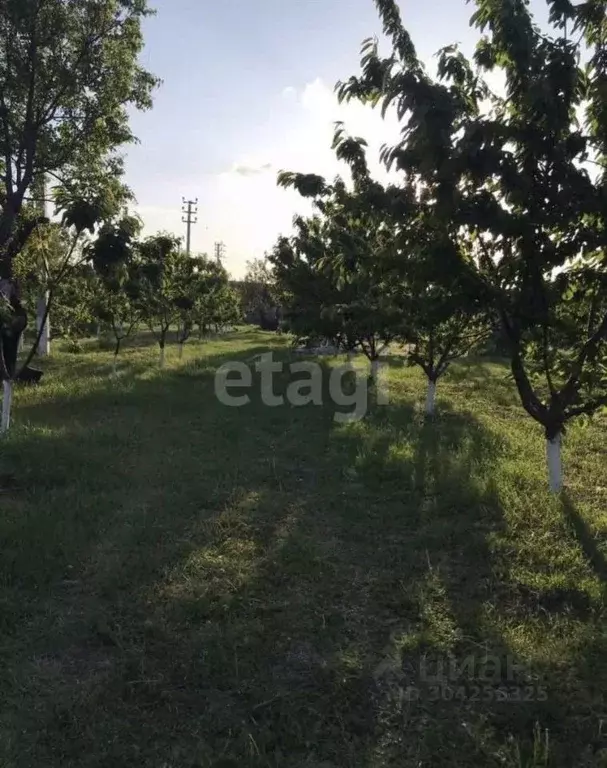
[0,331,607,768]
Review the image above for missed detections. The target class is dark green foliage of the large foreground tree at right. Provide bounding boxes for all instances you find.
[338,0,607,437]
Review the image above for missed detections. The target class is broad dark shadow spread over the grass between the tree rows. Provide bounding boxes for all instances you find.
[0,362,604,768]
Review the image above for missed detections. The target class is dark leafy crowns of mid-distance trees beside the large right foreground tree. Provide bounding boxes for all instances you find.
[273,124,487,372]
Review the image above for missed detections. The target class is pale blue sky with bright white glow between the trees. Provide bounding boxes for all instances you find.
[126,0,545,278]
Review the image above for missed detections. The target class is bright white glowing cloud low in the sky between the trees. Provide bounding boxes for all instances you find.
[134,79,398,276]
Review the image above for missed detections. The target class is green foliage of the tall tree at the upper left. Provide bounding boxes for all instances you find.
[0,0,157,268]
